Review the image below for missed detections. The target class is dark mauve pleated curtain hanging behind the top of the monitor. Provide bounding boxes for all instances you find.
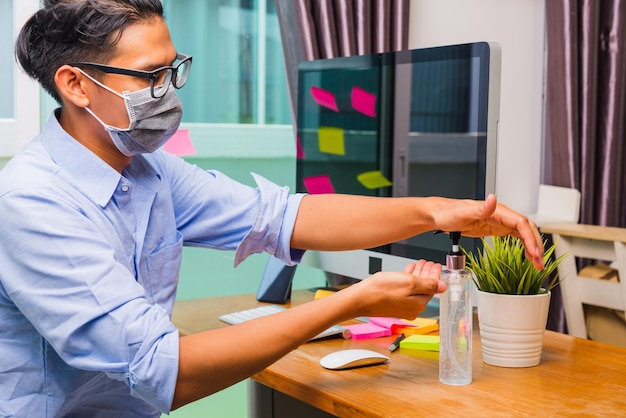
[275,0,409,126]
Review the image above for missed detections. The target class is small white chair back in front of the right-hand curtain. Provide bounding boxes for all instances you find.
[528,184,580,227]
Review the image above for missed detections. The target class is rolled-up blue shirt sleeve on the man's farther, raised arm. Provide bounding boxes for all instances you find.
[163,153,304,266]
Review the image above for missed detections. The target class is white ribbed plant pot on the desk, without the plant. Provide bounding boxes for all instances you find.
[477,290,550,367]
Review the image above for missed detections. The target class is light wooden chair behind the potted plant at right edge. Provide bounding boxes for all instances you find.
[541,223,626,338]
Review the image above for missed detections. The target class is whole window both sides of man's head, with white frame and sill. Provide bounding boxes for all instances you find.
[0,0,295,162]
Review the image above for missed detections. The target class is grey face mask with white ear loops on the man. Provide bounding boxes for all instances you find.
[79,69,183,157]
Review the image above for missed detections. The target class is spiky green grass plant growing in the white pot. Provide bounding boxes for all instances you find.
[462,236,569,295]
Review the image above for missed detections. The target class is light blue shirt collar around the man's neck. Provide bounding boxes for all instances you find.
[42,109,121,207]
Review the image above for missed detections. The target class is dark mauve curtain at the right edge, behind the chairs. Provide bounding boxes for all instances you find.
[542,0,626,331]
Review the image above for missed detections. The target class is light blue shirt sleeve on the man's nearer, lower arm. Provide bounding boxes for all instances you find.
[0,190,182,411]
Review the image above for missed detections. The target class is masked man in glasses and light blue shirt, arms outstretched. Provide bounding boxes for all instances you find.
[0,0,543,417]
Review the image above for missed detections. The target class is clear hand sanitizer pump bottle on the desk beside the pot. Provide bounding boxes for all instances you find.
[439,232,472,386]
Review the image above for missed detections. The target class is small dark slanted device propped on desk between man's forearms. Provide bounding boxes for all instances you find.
[256,256,296,304]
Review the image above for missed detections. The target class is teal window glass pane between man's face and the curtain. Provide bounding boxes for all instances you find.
[163,0,291,125]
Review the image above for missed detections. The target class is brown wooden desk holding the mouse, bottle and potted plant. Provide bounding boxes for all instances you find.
[173,291,626,418]
